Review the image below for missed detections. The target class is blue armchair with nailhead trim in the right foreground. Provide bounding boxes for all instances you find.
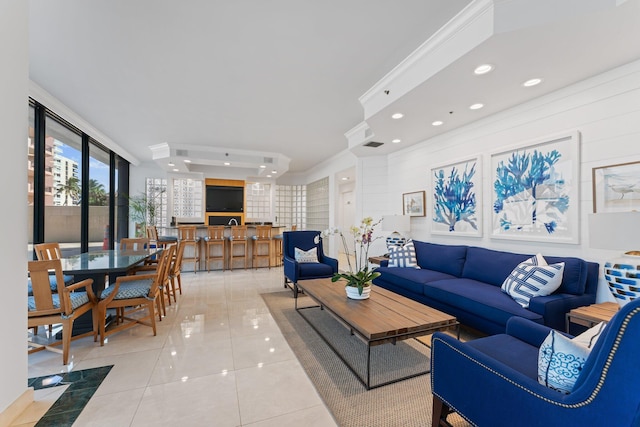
[431,300,640,427]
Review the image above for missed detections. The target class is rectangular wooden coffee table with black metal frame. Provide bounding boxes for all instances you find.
[294,279,460,390]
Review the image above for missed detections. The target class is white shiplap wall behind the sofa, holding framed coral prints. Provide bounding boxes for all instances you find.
[358,61,640,301]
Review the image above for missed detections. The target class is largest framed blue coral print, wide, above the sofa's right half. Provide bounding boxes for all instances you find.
[491,131,580,244]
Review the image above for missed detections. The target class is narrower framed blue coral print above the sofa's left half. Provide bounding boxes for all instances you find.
[431,157,482,237]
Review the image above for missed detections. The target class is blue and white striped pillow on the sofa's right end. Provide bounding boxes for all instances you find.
[501,254,564,308]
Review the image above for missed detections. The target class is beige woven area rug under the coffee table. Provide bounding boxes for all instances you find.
[262,291,476,427]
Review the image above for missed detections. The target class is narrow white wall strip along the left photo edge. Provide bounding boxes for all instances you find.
[0,0,29,418]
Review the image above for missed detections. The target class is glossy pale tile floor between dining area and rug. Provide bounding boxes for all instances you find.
[13,267,336,427]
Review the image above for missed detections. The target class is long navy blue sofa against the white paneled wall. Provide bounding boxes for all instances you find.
[373,240,599,335]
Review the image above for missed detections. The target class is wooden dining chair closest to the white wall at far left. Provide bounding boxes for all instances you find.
[27,259,97,365]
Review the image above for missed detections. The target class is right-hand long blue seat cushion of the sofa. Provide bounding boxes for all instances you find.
[422,280,544,325]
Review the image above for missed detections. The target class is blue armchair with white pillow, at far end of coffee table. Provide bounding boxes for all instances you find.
[282,231,338,297]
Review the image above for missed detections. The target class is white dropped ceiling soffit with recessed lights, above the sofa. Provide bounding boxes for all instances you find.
[345,0,640,156]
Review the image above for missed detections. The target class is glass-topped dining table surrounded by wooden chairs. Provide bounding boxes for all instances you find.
[57,247,162,338]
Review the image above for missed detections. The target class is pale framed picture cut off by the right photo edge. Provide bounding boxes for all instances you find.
[591,162,640,213]
